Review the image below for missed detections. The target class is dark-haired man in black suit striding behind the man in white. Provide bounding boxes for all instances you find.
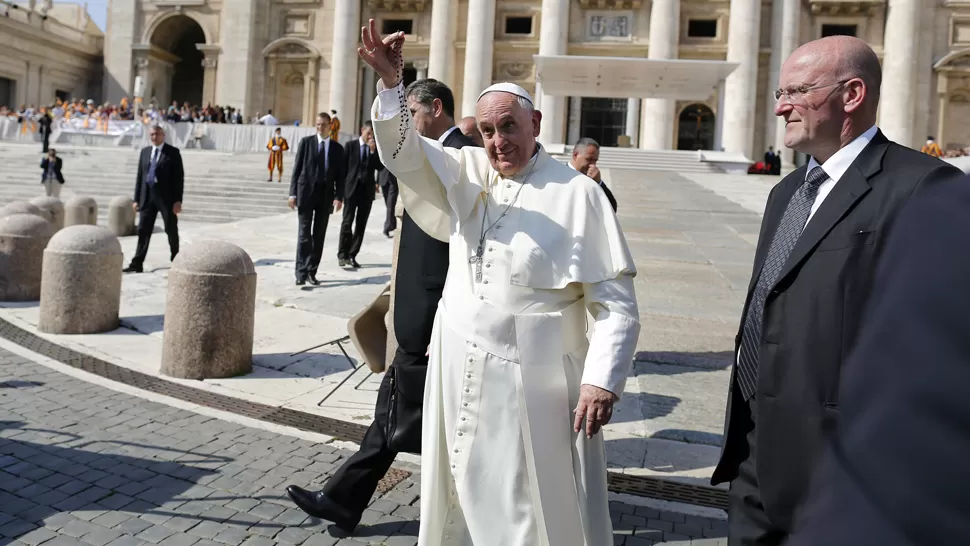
[286,79,474,532]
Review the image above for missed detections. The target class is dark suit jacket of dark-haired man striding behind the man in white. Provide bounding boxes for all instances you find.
[394,129,475,362]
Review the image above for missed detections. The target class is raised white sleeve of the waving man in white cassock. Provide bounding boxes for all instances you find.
[371,82,468,242]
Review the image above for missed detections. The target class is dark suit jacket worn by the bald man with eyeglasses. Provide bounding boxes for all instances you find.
[711,132,961,529]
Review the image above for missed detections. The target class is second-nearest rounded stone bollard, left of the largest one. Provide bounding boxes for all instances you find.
[38,225,124,334]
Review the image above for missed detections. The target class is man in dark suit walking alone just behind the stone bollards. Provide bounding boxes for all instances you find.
[124,125,185,273]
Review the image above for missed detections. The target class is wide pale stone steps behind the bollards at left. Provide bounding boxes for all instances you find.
[0,142,294,225]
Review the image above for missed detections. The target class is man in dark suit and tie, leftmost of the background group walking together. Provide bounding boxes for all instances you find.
[287,112,347,286]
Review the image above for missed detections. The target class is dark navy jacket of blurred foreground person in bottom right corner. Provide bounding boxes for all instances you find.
[789,174,970,546]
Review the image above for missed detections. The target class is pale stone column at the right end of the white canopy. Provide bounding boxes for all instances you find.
[718,0,761,159]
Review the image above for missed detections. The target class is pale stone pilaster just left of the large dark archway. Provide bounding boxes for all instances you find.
[102,0,141,104]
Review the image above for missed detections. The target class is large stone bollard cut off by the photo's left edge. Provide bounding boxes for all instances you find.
[0,214,54,301]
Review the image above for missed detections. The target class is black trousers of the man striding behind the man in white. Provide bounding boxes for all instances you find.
[323,356,397,517]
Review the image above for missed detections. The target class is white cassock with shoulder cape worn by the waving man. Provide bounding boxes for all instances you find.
[373,81,640,546]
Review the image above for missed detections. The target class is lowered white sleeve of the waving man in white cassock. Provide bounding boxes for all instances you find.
[583,274,640,398]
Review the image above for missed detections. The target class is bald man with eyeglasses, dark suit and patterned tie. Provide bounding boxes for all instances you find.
[711,36,960,546]
